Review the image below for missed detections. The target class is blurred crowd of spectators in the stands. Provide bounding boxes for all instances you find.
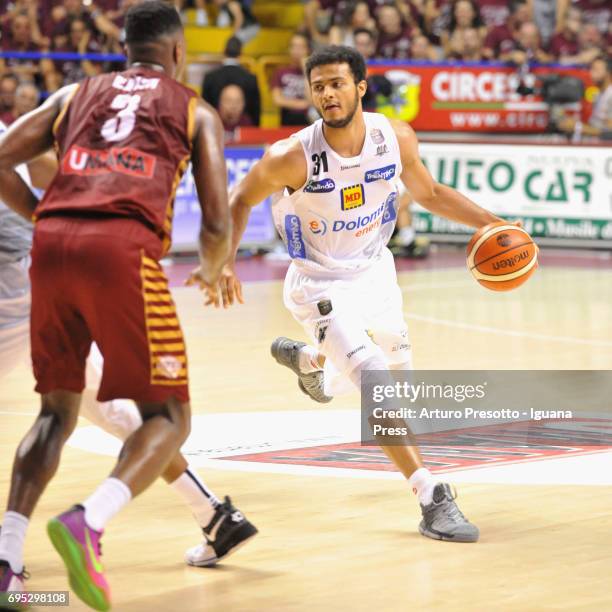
[0,0,612,133]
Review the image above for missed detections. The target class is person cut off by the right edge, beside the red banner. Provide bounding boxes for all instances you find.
[558,57,612,139]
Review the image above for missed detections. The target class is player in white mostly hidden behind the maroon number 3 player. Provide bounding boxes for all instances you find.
[0,122,257,592]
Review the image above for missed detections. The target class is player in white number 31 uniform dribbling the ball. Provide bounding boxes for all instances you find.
[209,47,510,542]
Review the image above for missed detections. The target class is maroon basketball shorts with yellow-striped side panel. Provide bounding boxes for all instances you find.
[30,217,189,402]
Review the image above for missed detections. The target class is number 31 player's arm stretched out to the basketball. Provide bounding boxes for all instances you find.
[392,121,503,227]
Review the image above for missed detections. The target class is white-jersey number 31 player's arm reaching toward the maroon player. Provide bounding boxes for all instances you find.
[220,138,308,307]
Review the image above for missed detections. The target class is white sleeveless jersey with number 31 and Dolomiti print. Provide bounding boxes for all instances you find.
[272,113,402,276]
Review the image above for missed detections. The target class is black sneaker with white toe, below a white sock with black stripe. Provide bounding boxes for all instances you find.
[185,496,257,567]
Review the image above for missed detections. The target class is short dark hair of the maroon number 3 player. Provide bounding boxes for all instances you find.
[125,0,183,45]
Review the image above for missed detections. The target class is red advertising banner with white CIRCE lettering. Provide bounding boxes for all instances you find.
[368,63,590,133]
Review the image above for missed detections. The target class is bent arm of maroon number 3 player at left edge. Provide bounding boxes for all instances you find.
[0,85,77,221]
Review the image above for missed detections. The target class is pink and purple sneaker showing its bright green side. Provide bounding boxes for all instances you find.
[47,505,111,610]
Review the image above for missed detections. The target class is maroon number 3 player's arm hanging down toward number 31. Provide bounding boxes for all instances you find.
[187,100,231,306]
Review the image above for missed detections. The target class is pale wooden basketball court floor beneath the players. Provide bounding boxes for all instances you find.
[0,246,612,612]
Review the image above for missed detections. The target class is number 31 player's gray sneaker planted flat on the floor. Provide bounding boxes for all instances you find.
[419,483,480,542]
